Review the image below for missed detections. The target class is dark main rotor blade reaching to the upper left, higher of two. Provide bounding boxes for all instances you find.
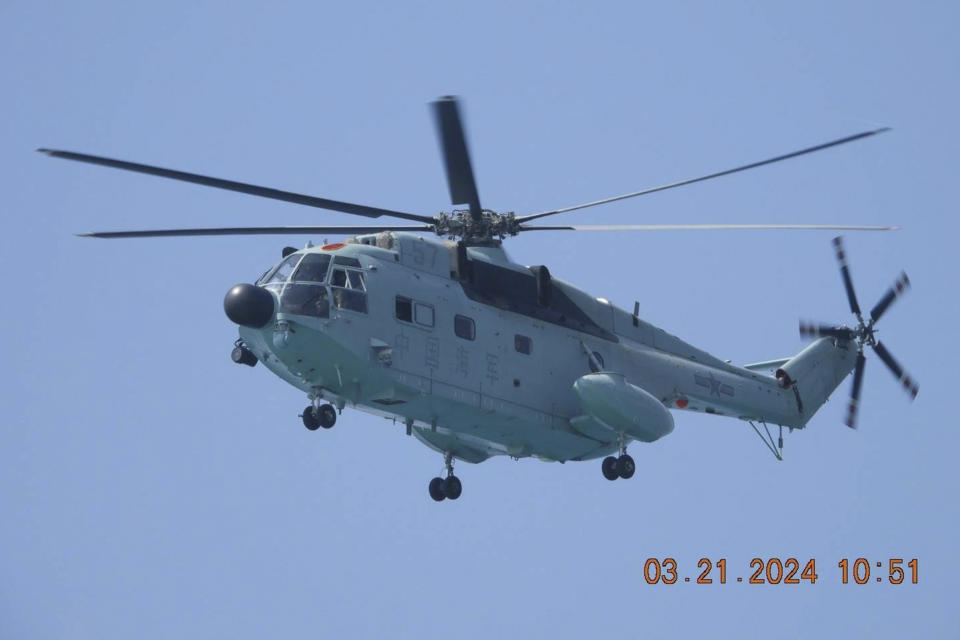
[37,149,433,223]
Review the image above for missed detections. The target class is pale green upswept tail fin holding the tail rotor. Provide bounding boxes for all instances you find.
[776,337,858,424]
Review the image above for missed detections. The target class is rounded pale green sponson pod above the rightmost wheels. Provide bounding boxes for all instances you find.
[573,373,673,442]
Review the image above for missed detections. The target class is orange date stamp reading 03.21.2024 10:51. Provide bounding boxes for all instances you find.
[643,557,918,584]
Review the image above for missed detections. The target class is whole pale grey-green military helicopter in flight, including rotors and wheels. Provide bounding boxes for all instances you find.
[39,97,918,501]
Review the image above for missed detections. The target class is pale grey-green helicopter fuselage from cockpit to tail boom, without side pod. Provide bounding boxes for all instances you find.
[240,233,852,462]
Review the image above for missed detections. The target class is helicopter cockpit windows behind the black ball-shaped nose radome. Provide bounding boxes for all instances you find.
[257,253,367,318]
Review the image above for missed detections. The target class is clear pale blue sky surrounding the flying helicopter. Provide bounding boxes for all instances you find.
[0,1,960,638]
